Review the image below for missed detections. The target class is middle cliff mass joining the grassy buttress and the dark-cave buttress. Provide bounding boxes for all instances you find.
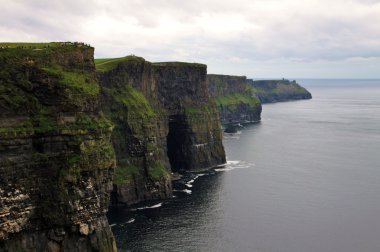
[96,56,225,204]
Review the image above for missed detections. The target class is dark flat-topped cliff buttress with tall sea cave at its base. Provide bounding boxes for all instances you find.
[153,62,226,171]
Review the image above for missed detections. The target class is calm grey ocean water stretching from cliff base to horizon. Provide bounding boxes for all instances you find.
[109,80,380,252]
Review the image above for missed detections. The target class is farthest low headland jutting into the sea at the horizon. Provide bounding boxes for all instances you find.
[249,79,312,103]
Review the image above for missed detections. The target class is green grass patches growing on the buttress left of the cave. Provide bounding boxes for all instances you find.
[103,85,169,185]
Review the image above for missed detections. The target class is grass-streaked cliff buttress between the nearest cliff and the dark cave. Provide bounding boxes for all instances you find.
[98,57,172,204]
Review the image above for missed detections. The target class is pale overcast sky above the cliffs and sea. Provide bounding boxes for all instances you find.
[0,0,380,79]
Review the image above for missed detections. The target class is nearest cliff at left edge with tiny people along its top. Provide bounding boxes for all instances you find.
[0,43,116,251]
